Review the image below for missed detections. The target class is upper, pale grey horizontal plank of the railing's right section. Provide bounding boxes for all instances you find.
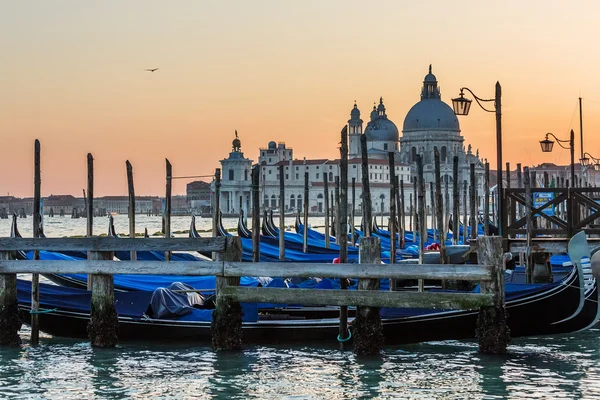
[224,262,491,281]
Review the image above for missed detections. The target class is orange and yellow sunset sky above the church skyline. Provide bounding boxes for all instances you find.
[0,0,600,196]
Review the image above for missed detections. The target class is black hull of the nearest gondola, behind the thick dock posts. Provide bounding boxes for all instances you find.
[19,269,585,344]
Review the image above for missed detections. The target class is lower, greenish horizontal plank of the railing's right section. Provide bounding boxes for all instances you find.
[223,286,493,310]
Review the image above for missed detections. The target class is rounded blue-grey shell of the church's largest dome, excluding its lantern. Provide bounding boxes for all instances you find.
[402,98,460,132]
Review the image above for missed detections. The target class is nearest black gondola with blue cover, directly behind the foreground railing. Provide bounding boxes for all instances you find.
[18,256,584,344]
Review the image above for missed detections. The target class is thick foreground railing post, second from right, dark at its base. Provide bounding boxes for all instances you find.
[352,237,383,356]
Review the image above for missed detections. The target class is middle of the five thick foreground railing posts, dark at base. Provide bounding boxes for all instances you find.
[210,236,242,350]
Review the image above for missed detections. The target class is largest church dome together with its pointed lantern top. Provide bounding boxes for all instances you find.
[402,65,460,132]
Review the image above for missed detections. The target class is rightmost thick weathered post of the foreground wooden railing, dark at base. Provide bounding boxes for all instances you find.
[476,236,510,354]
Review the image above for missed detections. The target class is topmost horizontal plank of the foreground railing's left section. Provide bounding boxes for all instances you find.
[0,237,226,252]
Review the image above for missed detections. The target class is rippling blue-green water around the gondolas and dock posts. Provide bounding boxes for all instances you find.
[0,216,600,399]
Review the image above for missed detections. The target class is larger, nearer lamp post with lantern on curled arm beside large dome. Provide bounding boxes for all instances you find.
[452,82,504,236]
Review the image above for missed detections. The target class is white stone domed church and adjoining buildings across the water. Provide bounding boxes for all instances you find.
[220,66,485,215]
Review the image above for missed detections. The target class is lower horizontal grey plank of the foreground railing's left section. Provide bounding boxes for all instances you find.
[0,260,223,276]
